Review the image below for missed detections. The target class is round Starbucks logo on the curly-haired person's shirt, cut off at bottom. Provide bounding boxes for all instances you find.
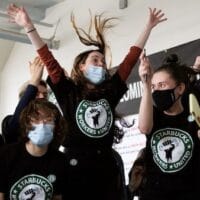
[10,174,53,200]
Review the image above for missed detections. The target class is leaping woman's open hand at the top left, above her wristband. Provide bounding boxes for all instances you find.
[7,4,33,28]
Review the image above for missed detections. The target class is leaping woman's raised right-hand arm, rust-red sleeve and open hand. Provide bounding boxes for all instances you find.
[118,8,167,81]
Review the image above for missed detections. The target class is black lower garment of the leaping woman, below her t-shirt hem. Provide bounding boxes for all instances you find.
[65,148,123,200]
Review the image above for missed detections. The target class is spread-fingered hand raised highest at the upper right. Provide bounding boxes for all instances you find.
[148,8,167,28]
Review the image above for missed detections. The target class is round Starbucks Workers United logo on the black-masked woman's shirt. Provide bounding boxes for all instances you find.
[151,128,194,173]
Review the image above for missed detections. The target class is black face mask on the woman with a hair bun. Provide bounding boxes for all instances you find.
[152,87,178,111]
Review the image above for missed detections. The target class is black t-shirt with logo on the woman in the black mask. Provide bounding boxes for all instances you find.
[144,109,200,200]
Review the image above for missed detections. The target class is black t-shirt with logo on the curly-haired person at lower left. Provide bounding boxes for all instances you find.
[0,143,67,200]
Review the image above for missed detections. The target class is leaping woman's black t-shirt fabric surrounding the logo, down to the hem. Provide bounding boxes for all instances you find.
[47,73,127,148]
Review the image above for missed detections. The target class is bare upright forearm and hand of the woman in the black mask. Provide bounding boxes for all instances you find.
[138,52,153,134]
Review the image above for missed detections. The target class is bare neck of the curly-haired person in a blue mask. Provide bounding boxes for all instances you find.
[26,141,48,157]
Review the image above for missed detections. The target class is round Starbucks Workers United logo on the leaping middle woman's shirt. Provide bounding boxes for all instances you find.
[76,99,113,138]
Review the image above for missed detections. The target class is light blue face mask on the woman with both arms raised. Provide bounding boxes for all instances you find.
[84,65,106,85]
